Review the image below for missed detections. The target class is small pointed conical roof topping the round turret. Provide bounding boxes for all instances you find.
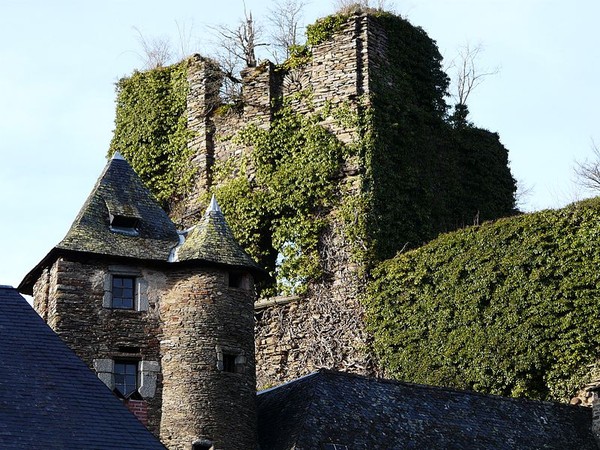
[177,196,263,272]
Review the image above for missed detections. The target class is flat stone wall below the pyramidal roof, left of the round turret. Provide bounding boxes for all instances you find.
[34,258,164,435]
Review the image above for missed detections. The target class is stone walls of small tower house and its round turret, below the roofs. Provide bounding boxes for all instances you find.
[34,258,256,450]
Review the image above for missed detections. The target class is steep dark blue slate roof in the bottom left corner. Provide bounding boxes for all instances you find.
[0,286,164,450]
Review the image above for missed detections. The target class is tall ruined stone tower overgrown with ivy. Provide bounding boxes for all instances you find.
[111,8,515,394]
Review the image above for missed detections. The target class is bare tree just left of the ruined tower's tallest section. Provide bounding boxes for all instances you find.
[267,0,306,63]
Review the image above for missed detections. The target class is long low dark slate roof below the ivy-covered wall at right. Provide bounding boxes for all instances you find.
[257,370,598,450]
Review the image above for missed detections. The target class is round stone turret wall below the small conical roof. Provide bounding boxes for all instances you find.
[160,270,256,450]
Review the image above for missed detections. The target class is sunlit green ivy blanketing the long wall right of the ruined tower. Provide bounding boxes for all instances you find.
[366,198,600,400]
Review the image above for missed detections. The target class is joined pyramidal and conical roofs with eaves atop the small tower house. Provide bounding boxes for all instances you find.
[19,153,267,294]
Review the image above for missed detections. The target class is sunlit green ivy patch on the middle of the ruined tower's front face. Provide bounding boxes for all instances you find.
[214,105,346,294]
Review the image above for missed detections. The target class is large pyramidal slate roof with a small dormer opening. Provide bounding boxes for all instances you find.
[56,153,179,261]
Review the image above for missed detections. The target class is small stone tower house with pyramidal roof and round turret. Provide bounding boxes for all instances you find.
[19,154,264,450]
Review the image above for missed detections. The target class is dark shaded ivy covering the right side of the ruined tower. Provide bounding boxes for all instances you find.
[365,12,516,261]
